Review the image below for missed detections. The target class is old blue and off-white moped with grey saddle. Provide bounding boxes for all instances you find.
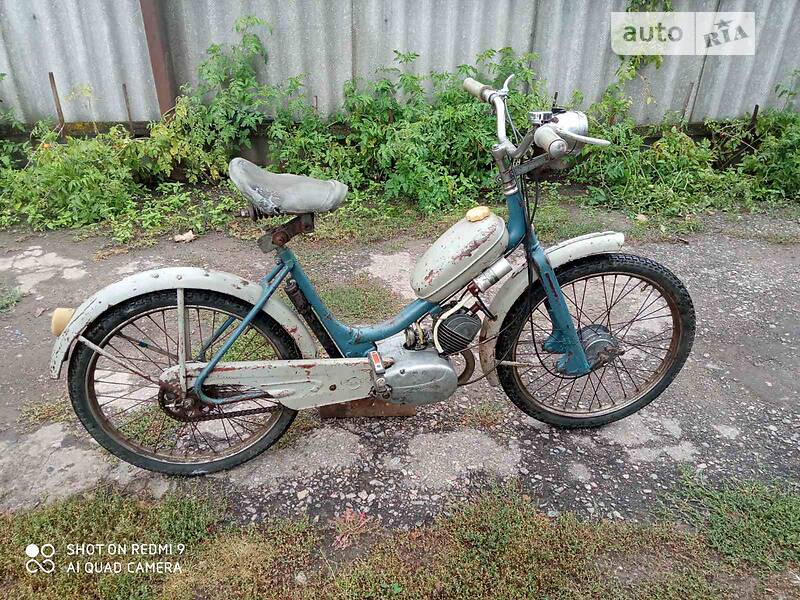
[51,78,695,475]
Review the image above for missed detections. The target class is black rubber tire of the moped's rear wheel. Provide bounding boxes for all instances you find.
[68,290,302,475]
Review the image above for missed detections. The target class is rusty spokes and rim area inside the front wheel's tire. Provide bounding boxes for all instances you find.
[506,270,680,418]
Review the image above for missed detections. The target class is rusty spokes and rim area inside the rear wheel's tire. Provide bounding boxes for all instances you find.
[86,302,284,464]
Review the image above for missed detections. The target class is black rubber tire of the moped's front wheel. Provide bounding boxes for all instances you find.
[495,254,695,429]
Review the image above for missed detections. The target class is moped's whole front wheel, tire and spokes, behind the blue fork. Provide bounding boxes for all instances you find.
[495,254,695,428]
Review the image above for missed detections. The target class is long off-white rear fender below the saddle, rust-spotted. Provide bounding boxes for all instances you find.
[50,267,317,379]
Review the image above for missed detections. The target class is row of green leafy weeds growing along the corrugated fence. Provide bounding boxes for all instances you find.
[0,13,800,237]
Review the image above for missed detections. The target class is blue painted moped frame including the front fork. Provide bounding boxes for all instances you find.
[194,191,590,404]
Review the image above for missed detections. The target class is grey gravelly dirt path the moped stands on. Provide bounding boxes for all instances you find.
[0,219,800,527]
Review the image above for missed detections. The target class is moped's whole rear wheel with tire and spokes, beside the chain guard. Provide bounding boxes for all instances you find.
[69,290,301,475]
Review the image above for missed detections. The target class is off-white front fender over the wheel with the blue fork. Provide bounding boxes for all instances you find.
[479,231,625,386]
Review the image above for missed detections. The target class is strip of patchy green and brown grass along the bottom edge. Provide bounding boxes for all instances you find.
[0,480,800,600]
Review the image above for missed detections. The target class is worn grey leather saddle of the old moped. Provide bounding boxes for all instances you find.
[228,158,347,216]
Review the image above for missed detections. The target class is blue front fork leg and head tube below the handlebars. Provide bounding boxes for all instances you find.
[506,188,591,377]
